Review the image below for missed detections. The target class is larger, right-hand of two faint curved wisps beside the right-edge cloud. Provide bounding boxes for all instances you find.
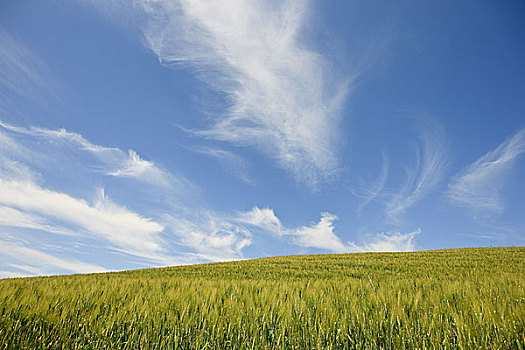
[387,120,447,219]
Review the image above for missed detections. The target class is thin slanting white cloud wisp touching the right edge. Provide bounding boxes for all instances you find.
[448,129,525,213]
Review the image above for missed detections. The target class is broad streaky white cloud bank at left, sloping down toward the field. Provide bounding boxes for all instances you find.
[0,122,251,272]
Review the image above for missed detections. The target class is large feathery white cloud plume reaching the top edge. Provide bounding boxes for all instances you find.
[91,0,351,188]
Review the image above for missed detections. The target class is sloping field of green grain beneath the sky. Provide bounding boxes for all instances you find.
[0,247,525,349]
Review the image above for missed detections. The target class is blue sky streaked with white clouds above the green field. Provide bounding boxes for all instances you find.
[0,0,525,278]
